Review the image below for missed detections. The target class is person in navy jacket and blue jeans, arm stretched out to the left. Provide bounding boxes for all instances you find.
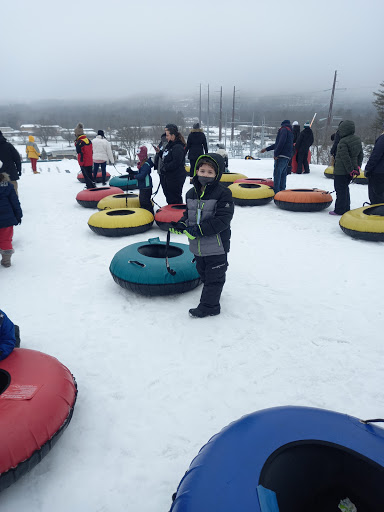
[260,119,293,194]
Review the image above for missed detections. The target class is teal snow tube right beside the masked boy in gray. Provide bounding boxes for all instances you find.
[109,238,200,295]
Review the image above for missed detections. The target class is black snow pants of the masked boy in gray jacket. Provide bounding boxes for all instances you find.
[195,253,228,313]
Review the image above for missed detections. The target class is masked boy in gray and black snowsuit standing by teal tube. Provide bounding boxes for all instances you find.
[171,153,234,318]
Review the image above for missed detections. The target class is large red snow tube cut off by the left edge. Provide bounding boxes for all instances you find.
[0,348,77,491]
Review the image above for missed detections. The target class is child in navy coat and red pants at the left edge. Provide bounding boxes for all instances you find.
[0,161,23,267]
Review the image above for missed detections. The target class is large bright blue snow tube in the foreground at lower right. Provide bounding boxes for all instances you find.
[171,407,384,512]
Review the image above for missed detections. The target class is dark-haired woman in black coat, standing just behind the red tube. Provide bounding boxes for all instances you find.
[155,124,187,204]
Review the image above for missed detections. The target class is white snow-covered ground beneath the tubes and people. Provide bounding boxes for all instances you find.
[0,159,384,512]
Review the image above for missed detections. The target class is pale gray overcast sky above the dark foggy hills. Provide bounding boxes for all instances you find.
[0,0,384,103]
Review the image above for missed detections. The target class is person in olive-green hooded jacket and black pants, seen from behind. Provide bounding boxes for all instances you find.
[329,121,364,215]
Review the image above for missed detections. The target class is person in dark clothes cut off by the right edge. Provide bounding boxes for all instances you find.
[364,123,384,204]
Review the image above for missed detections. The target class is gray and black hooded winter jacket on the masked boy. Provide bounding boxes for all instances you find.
[181,153,234,256]
